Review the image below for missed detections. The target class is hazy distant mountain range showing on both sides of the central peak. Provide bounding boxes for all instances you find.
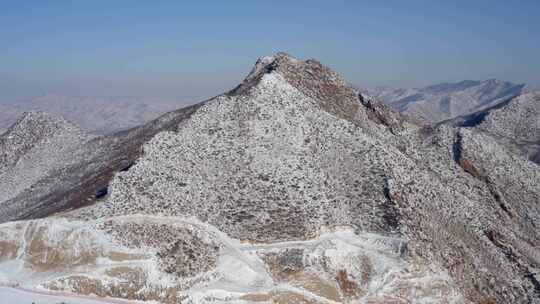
[0,79,533,134]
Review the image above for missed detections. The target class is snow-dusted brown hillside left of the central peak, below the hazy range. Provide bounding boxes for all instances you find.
[0,105,199,222]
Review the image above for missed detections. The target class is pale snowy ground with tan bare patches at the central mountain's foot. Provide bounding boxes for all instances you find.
[0,216,461,303]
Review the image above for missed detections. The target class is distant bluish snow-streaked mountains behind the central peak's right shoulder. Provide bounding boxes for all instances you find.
[367,79,526,123]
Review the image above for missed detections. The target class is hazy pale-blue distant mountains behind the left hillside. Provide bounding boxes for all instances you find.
[0,95,179,134]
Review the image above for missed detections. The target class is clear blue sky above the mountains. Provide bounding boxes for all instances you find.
[0,0,540,102]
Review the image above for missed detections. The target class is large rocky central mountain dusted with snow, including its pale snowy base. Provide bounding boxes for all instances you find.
[0,53,540,303]
